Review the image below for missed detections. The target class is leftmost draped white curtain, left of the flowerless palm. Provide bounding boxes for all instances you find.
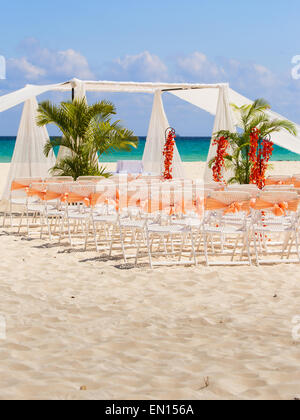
[2,97,55,200]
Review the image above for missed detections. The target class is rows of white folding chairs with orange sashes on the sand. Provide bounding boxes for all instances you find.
[3,180,300,267]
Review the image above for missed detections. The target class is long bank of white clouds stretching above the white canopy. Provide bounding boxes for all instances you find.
[1,42,300,129]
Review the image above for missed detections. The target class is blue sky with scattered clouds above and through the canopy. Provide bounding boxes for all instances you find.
[0,0,300,135]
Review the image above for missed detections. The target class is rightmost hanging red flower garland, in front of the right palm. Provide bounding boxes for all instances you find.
[249,128,274,190]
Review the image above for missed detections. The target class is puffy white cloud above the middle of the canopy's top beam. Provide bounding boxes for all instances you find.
[106,51,168,82]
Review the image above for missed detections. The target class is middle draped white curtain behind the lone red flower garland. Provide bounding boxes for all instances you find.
[143,90,184,178]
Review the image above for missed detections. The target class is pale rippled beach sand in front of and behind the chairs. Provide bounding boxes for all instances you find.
[0,162,300,400]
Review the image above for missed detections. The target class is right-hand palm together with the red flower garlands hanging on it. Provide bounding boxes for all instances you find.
[209,99,297,186]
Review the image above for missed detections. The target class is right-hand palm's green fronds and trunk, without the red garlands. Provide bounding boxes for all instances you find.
[209,99,297,184]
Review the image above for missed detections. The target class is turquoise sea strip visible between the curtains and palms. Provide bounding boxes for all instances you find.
[0,137,300,163]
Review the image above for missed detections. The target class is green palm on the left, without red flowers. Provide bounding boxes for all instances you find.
[37,99,138,180]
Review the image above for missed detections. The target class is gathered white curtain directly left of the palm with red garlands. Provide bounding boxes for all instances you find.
[204,85,236,182]
